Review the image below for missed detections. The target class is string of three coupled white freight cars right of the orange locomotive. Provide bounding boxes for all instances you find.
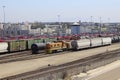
[71,37,112,50]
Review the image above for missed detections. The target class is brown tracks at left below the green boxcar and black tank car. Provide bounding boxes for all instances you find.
[0,42,119,64]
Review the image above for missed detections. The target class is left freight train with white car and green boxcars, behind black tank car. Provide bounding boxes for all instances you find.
[0,38,57,53]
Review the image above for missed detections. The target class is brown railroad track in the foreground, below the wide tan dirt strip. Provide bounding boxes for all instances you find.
[1,50,120,80]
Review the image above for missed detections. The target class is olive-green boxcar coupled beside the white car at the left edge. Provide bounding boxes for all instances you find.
[8,40,27,52]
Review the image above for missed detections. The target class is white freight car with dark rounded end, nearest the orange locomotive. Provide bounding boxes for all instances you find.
[71,39,90,50]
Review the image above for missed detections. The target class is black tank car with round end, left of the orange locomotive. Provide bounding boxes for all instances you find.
[31,43,46,54]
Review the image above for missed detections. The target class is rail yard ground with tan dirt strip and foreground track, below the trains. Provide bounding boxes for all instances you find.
[0,43,120,80]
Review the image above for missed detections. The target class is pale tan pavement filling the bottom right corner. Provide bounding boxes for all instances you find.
[71,60,120,80]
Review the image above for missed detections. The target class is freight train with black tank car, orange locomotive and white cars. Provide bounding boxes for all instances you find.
[31,37,120,54]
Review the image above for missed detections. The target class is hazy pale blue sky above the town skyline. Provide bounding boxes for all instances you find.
[0,0,120,22]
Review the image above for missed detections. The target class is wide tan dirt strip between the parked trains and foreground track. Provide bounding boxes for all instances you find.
[0,43,120,79]
